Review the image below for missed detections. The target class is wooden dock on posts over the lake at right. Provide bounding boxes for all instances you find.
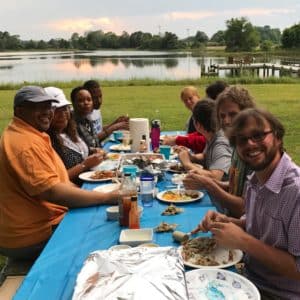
[209,63,300,77]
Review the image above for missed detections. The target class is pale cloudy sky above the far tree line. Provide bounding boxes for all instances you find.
[0,0,300,40]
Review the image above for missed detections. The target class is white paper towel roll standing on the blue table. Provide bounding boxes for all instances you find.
[129,118,150,152]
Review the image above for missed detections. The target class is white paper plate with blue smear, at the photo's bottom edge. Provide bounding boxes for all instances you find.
[185,269,260,300]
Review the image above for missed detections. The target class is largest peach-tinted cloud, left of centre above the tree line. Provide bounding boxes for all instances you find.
[47,18,114,33]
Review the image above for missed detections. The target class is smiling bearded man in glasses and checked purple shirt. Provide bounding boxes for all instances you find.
[195,109,300,299]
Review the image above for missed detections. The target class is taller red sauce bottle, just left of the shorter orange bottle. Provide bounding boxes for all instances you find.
[119,173,137,226]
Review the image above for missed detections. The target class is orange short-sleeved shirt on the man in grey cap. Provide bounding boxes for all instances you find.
[0,117,71,248]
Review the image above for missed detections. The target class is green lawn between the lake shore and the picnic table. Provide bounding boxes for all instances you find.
[0,81,300,164]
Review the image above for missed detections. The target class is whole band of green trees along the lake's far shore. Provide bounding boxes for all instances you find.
[0,17,300,51]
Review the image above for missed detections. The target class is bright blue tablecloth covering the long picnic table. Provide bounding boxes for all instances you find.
[13,132,215,300]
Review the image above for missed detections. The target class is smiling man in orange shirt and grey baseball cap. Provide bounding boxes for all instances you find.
[0,86,119,259]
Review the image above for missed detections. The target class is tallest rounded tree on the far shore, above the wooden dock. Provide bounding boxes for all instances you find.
[225,17,259,51]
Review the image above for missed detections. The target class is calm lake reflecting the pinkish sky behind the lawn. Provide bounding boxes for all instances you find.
[0,50,292,84]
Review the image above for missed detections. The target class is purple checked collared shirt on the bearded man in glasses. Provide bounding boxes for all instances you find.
[244,153,300,300]
